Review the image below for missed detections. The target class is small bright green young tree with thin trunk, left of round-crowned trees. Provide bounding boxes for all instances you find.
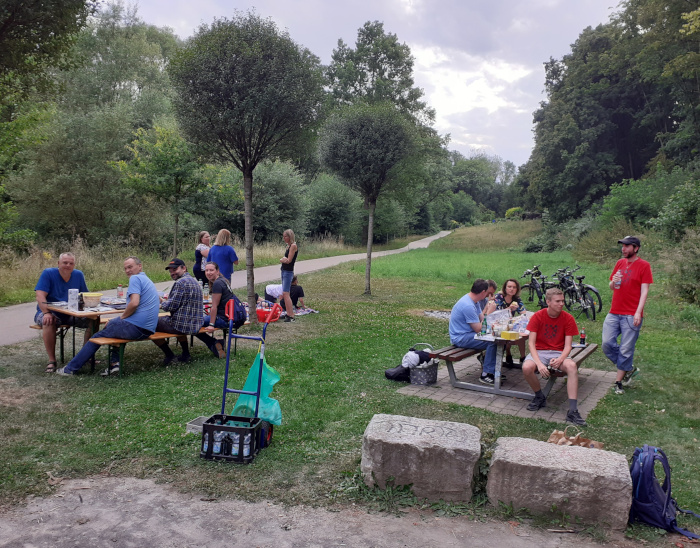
[115,126,204,257]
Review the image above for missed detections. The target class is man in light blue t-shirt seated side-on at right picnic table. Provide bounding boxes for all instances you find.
[450,278,505,386]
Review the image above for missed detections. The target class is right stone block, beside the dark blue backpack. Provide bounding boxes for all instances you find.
[486,438,632,530]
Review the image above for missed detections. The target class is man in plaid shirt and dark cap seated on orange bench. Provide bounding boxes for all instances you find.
[153,258,204,365]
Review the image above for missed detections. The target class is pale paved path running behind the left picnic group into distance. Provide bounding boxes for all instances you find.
[0,230,450,346]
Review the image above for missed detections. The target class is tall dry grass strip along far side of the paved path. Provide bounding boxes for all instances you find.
[0,235,422,306]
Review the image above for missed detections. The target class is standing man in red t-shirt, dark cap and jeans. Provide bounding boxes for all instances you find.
[603,236,654,394]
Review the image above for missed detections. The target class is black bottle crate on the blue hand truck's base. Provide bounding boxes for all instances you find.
[199,415,270,464]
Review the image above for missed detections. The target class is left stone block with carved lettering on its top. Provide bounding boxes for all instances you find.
[362,415,481,501]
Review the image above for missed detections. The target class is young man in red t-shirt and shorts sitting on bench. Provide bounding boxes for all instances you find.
[523,288,586,426]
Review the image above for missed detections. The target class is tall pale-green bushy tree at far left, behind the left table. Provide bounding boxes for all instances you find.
[6,5,177,243]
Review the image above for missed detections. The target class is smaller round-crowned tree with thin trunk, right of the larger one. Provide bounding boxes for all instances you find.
[319,103,413,295]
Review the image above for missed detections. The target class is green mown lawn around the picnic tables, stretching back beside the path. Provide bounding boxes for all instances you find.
[0,223,700,537]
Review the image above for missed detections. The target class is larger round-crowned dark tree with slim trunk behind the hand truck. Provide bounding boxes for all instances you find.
[169,13,322,306]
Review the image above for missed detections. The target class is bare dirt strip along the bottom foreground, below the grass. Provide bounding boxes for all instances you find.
[0,477,632,548]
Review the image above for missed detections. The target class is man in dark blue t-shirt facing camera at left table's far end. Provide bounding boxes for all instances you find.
[34,253,90,373]
